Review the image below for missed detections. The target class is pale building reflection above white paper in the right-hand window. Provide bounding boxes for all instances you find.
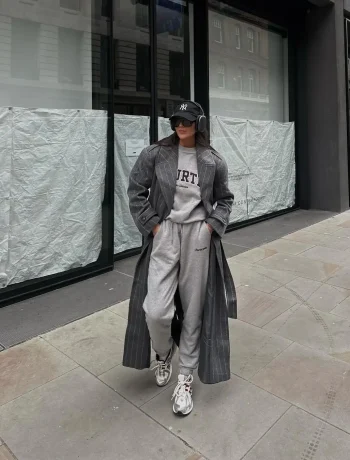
[209,7,288,122]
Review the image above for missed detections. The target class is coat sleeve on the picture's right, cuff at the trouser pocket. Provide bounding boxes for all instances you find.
[207,158,234,237]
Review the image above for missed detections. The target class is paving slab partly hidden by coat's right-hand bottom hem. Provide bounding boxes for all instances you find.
[229,320,292,379]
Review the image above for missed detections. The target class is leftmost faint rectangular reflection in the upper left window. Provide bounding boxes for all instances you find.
[11,19,40,80]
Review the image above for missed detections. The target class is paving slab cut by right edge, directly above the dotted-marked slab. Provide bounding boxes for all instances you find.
[252,343,350,433]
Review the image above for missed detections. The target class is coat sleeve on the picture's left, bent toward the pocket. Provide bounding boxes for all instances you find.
[128,148,160,236]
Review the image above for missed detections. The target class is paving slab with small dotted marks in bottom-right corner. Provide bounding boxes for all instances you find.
[244,407,350,460]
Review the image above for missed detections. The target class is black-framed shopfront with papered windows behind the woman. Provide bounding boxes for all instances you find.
[0,0,350,305]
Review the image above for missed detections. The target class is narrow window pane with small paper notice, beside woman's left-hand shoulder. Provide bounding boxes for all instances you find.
[114,0,151,254]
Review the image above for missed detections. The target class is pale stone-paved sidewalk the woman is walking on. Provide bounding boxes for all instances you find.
[0,212,350,460]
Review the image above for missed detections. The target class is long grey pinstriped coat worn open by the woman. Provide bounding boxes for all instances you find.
[123,141,237,383]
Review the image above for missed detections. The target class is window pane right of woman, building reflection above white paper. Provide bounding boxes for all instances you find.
[209,1,295,222]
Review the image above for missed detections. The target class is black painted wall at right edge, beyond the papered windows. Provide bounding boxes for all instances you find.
[297,0,349,212]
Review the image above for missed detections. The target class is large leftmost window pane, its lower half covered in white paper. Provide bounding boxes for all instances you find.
[0,0,108,287]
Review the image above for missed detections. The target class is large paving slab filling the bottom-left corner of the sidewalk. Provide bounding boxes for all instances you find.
[0,368,195,460]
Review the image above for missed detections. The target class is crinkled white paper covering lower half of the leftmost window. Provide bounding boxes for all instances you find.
[0,108,107,287]
